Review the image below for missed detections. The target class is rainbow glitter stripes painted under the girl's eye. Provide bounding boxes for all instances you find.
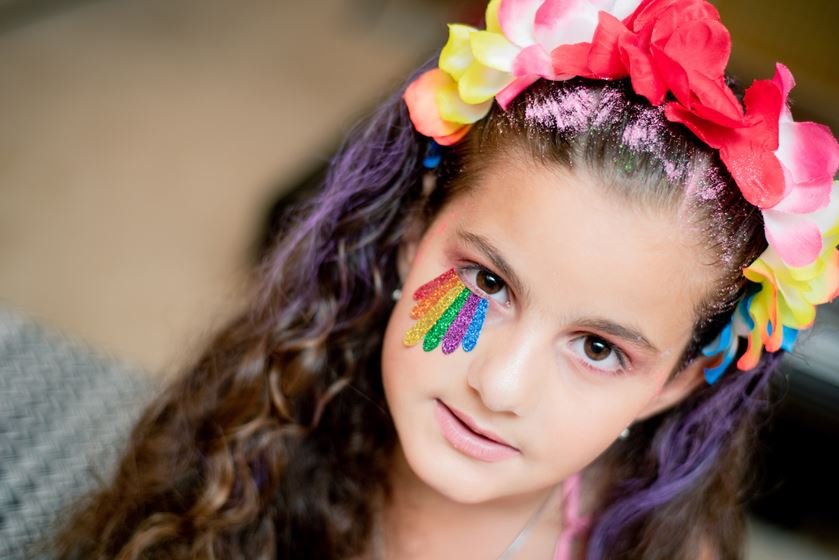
[402,268,489,354]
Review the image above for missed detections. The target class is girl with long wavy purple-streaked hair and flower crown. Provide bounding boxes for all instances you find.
[54,0,839,560]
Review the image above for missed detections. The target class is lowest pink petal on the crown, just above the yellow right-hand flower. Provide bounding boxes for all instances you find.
[763,209,822,267]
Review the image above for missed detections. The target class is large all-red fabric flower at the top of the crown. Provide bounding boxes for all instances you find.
[551,0,743,126]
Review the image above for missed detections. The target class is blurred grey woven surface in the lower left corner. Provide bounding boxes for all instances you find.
[0,308,154,560]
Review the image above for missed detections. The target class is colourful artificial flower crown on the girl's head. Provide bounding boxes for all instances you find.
[404,0,839,383]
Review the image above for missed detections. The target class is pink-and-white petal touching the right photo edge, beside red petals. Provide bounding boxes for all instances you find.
[775,122,839,183]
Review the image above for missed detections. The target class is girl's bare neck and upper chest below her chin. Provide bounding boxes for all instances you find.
[381,446,562,559]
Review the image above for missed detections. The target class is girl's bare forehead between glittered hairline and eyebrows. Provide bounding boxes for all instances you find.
[428,160,715,346]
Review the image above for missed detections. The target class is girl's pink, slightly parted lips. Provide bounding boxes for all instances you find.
[434,399,521,463]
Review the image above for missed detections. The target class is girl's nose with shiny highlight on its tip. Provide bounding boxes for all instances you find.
[466,329,551,416]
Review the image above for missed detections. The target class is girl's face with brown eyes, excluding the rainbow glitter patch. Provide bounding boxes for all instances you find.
[382,158,713,503]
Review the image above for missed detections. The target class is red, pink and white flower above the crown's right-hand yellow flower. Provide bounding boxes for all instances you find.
[665,64,839,267]
